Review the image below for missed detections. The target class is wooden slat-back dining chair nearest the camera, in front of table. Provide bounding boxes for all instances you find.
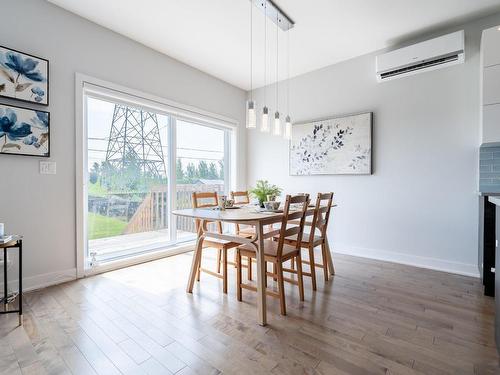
[237,195,309,315]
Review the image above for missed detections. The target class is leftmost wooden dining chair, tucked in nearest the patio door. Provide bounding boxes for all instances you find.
[192,192,238,293]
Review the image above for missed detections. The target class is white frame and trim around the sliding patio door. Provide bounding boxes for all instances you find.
[75,73,238,278]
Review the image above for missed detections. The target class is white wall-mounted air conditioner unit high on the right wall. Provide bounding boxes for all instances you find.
[376,30,464,82]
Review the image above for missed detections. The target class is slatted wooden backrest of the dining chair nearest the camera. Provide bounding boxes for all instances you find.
[276,194,309,259]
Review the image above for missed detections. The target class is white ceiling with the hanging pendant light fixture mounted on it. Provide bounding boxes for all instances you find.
[48,0,500,90]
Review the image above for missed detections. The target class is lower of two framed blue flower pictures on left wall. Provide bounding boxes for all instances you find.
[0,104,50,157]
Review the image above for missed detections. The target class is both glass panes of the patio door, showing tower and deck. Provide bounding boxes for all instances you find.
[84,86,232,268]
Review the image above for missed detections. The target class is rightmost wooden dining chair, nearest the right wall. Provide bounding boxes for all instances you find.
[284,193,335,290]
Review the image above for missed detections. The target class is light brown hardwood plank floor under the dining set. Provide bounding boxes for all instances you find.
[0,254,500,375]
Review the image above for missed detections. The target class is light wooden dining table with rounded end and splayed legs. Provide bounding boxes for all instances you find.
[172,206,334,326]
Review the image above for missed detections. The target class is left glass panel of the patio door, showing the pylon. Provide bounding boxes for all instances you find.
[87,97,171,262]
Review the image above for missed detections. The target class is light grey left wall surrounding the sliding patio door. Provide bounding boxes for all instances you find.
[0,0,245,288]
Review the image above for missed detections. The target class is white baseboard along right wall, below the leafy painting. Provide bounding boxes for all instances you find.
[333,245,479,277]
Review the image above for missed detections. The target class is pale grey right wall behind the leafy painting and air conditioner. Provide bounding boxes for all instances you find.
[247,15,500,275]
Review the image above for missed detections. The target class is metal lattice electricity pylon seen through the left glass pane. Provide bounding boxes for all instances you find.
[106,104,167,178]
